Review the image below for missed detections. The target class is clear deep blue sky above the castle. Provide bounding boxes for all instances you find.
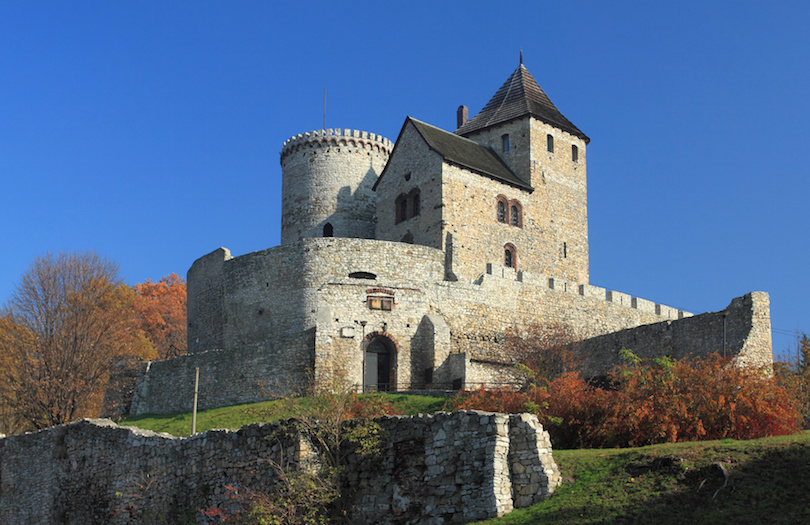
[0,1,810,353]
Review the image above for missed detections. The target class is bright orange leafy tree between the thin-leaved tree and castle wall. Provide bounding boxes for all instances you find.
[135,273,187,359]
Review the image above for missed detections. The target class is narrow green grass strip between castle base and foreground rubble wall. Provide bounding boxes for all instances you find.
[119,394,447,436]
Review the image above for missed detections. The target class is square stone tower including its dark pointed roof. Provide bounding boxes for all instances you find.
[456,61,590,283]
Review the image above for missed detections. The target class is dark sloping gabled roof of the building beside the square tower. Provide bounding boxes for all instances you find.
[374,117,534,192]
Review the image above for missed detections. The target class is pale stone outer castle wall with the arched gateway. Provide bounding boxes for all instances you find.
[142,238,771,414]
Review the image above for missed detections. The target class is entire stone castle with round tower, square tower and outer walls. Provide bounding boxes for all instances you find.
[112,57,772,413]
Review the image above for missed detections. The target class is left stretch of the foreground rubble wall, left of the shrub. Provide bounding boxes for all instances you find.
[0,419,306,525]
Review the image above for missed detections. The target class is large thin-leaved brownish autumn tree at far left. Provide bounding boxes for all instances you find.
[0,252,143,428]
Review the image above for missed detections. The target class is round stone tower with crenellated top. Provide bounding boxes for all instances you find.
[281,129,394,244]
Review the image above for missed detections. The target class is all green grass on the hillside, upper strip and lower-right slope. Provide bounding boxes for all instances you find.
[121,395,810,525]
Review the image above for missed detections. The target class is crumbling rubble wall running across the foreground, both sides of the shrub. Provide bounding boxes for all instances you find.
[0,411,560,525]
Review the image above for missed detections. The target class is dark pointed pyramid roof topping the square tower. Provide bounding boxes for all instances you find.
[456,64,590,143]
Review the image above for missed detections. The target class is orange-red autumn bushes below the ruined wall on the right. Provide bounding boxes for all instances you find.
[451,355,802,448]
